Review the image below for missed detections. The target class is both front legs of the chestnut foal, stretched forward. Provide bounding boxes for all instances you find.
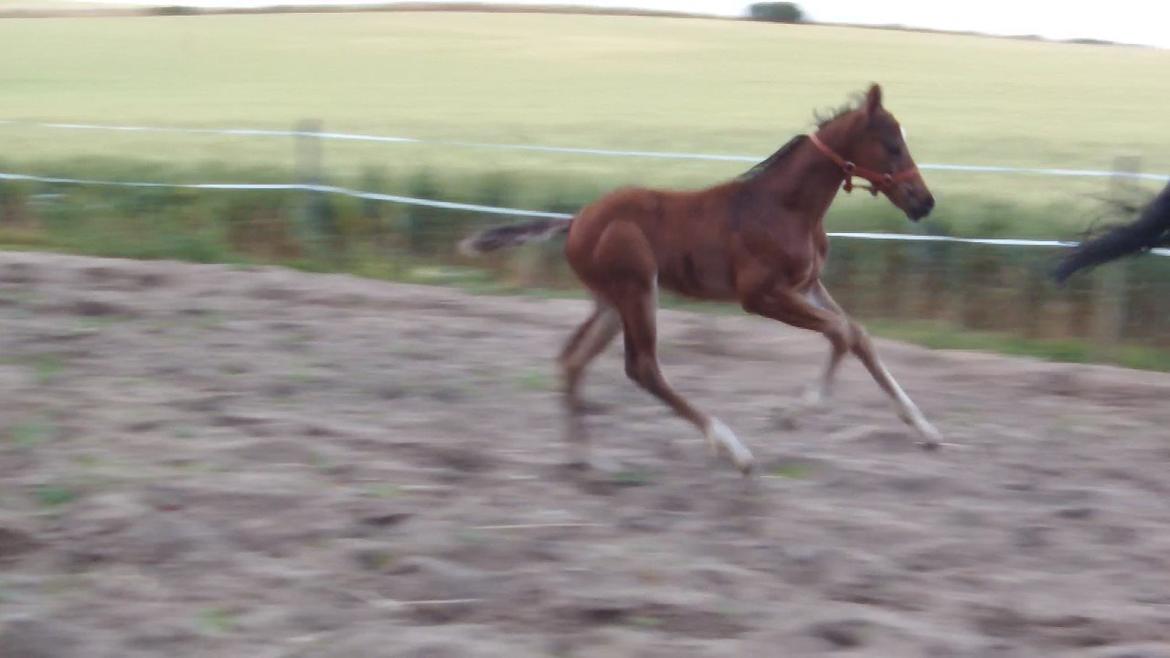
[744,282,941,448]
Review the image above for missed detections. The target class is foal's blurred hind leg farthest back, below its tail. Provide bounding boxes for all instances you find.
[557,301,621,466]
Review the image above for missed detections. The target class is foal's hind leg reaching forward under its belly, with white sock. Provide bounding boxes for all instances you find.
[613,276,753,474]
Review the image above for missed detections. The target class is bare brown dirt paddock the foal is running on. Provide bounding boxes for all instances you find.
[0,248,1170,658]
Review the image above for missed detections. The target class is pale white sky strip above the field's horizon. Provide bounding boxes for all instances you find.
[86,0,1170,48]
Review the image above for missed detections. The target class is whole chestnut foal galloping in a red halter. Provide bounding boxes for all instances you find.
[460,84,940,474]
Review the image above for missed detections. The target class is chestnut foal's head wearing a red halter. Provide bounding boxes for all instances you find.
[820,84,935,221]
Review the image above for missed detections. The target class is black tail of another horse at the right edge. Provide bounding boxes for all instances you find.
[1052,179,1170,283]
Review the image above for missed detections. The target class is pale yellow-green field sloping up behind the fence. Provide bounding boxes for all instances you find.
[0,13,1170,235]
